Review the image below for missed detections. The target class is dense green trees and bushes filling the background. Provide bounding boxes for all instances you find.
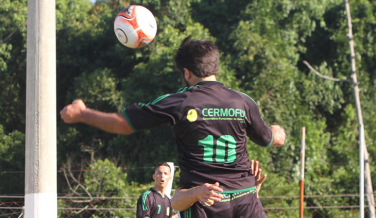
[0,0,376,217]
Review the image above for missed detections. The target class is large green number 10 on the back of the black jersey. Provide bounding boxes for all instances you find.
[198,135,236,163]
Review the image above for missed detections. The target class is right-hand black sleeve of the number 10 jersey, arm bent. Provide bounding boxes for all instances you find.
[247,95,273,147]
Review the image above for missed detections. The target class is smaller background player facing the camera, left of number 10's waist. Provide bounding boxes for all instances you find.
[137,162,178,218]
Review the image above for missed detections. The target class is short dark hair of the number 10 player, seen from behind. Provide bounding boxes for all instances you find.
[174,36,219,77]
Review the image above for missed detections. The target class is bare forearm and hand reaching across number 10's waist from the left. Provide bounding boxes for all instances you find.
[171,182,223,211]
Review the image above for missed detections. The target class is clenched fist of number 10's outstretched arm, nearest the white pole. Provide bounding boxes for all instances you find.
[60,99,86,123]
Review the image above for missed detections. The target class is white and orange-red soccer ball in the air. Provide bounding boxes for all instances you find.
[114,5,157,48]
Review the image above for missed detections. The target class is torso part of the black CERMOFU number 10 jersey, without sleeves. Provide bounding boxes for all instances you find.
[174,81,272,189]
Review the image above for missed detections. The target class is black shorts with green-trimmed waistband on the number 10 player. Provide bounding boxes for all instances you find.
[180,190,266,218]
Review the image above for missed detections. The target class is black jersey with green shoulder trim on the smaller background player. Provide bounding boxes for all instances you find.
[137,188,172,218]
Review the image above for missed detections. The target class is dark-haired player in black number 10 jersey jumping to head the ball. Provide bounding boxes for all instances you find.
[60,37,286,218]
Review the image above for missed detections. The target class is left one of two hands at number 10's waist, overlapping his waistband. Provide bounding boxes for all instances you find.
[196,182,223,206]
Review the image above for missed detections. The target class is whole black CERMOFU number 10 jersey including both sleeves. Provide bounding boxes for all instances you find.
[124,81,273,191]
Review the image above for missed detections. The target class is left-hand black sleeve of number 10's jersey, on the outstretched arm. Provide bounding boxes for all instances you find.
[123,94,184,131]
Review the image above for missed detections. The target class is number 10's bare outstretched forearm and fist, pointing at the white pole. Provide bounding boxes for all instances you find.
[60,99,133,134]
